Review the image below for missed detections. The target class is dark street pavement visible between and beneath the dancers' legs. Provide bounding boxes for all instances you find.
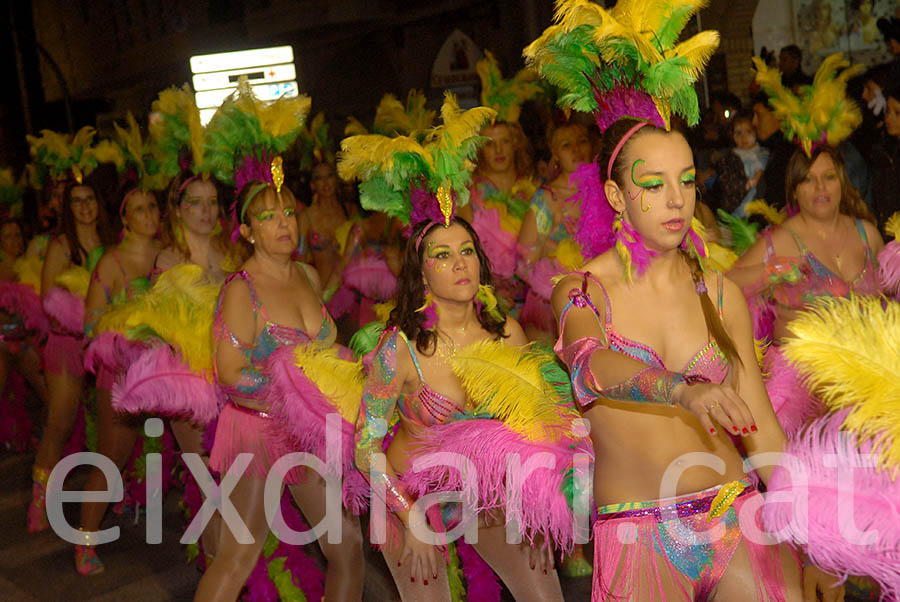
[0,451,590,602]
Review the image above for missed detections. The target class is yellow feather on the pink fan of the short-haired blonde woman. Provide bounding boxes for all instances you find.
[294,344,365,424]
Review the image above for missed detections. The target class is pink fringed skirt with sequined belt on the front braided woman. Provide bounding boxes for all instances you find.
[591,481,800,602]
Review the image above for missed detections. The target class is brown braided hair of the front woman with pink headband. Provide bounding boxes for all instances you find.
[598,118,742,366]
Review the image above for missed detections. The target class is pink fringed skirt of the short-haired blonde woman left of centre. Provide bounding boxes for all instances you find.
[209,401,305,485]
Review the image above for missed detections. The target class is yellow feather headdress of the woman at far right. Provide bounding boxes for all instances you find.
[753,52,863,157]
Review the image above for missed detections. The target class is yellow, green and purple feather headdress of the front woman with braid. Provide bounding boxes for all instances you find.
[524,0,719,131]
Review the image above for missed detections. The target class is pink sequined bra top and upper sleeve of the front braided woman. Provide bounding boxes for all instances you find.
[553,272,728,406]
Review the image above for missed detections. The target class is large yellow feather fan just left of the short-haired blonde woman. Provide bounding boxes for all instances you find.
[95,264,220,373]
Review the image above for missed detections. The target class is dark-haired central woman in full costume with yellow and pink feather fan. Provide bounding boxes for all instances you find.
[338,95,577,600]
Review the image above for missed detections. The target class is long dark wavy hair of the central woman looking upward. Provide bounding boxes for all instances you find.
[387,217,506,355]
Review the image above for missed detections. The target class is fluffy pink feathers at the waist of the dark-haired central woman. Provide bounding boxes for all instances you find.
[403,419,593,550]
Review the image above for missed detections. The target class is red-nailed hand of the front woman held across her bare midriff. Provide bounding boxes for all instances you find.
[674,383,758,436]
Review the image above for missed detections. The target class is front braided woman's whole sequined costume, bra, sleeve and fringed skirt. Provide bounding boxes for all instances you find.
[554,273,784,602]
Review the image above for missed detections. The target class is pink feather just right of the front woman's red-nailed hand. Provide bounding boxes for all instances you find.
[763,347,825,437]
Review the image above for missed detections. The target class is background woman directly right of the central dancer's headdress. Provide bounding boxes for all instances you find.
[460,50,539,311]
